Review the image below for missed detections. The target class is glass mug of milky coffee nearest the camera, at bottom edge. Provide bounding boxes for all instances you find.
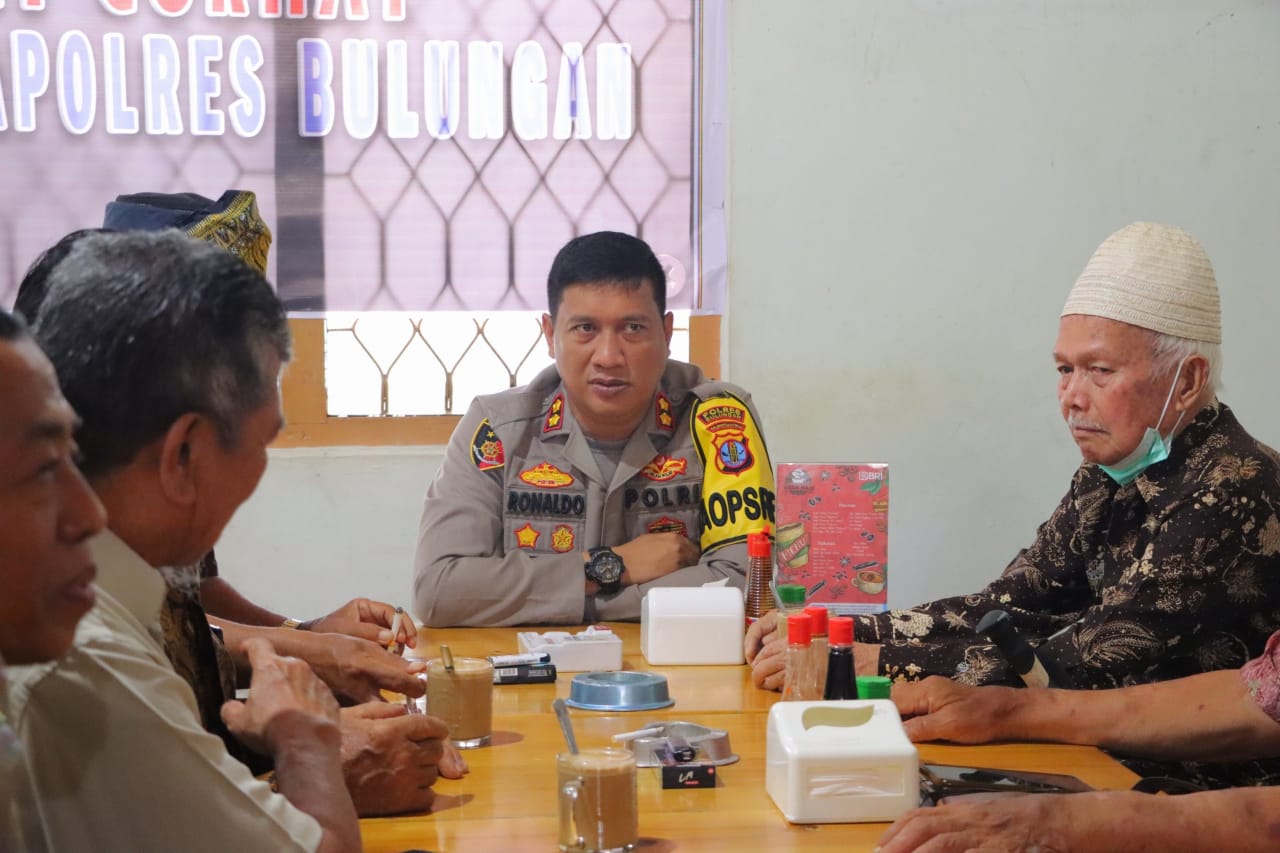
[556,749,640,853]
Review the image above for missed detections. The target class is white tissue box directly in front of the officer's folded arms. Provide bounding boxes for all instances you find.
[640,587,746,665]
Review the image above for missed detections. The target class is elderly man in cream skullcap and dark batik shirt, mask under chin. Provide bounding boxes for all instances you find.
[746,223,1280,701]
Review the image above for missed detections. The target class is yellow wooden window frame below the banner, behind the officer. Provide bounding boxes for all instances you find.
[271,315,721,448]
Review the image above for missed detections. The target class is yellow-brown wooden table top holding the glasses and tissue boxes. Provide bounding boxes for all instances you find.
[361,624,1137,853]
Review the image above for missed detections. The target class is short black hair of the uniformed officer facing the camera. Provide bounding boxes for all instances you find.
[547,231,667,316]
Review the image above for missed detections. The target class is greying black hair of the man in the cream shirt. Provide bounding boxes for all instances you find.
[36,229,289,478]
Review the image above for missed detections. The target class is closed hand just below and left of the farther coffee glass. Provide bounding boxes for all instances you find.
[342,702,455,817]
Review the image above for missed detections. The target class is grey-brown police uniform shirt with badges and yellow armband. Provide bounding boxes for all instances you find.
[413,361,773,626]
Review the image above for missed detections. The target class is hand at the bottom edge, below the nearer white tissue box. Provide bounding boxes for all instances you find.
[876,794,1075,853]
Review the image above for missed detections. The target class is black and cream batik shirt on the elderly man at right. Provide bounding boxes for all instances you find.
[855,401,1280,688]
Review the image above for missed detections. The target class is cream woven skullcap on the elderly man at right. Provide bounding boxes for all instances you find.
[1062,222,1222,343]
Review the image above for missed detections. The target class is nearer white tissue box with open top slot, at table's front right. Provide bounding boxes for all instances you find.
[764,699,920,824]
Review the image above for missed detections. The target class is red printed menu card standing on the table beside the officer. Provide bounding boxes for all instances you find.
[774,462,888,616]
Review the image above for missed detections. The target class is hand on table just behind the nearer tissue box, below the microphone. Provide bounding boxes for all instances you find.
[893,675,1027,743]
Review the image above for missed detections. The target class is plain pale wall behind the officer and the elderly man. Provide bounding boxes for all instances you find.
[219,0,1280,616]
